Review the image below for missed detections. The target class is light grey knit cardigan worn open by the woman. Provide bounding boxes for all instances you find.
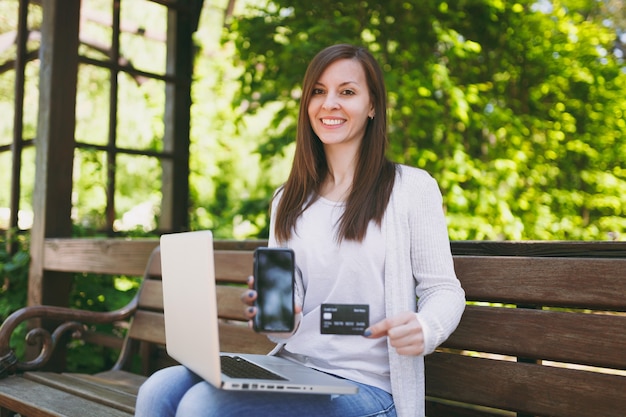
[269,165,465,417]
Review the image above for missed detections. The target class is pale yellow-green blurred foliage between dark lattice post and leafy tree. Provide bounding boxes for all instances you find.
[190,1,298,239]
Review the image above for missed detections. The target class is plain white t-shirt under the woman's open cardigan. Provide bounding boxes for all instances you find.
[276,194,391,392]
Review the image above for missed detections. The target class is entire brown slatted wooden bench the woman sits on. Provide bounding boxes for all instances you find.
[0,239,626,417]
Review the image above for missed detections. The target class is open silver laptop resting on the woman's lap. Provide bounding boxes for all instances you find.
[161,230,358,394]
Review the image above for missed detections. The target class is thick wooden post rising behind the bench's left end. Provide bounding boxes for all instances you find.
[28,0,80,305]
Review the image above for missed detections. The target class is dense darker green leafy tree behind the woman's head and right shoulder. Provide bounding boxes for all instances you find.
[226,0,626,240]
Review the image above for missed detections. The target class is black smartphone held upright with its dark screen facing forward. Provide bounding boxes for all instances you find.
[253,248,296,332]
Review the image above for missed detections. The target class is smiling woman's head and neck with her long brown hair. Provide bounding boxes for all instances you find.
[276,45,395,240]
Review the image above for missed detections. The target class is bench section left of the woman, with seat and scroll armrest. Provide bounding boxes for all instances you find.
[0,239,273,417]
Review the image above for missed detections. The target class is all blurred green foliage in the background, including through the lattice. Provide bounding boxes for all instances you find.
[0,0,626,239]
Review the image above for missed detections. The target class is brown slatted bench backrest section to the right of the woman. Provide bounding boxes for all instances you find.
[426,245,626,417]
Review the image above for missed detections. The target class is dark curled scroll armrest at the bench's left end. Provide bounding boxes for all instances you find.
[0,297,138,379]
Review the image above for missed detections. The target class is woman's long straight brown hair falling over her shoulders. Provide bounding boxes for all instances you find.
[274,44,395,242]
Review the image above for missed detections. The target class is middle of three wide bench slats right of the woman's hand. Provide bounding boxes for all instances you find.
[443,306,626,369]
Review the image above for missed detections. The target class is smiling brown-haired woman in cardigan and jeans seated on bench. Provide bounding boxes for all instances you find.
[136,44,465,417]
